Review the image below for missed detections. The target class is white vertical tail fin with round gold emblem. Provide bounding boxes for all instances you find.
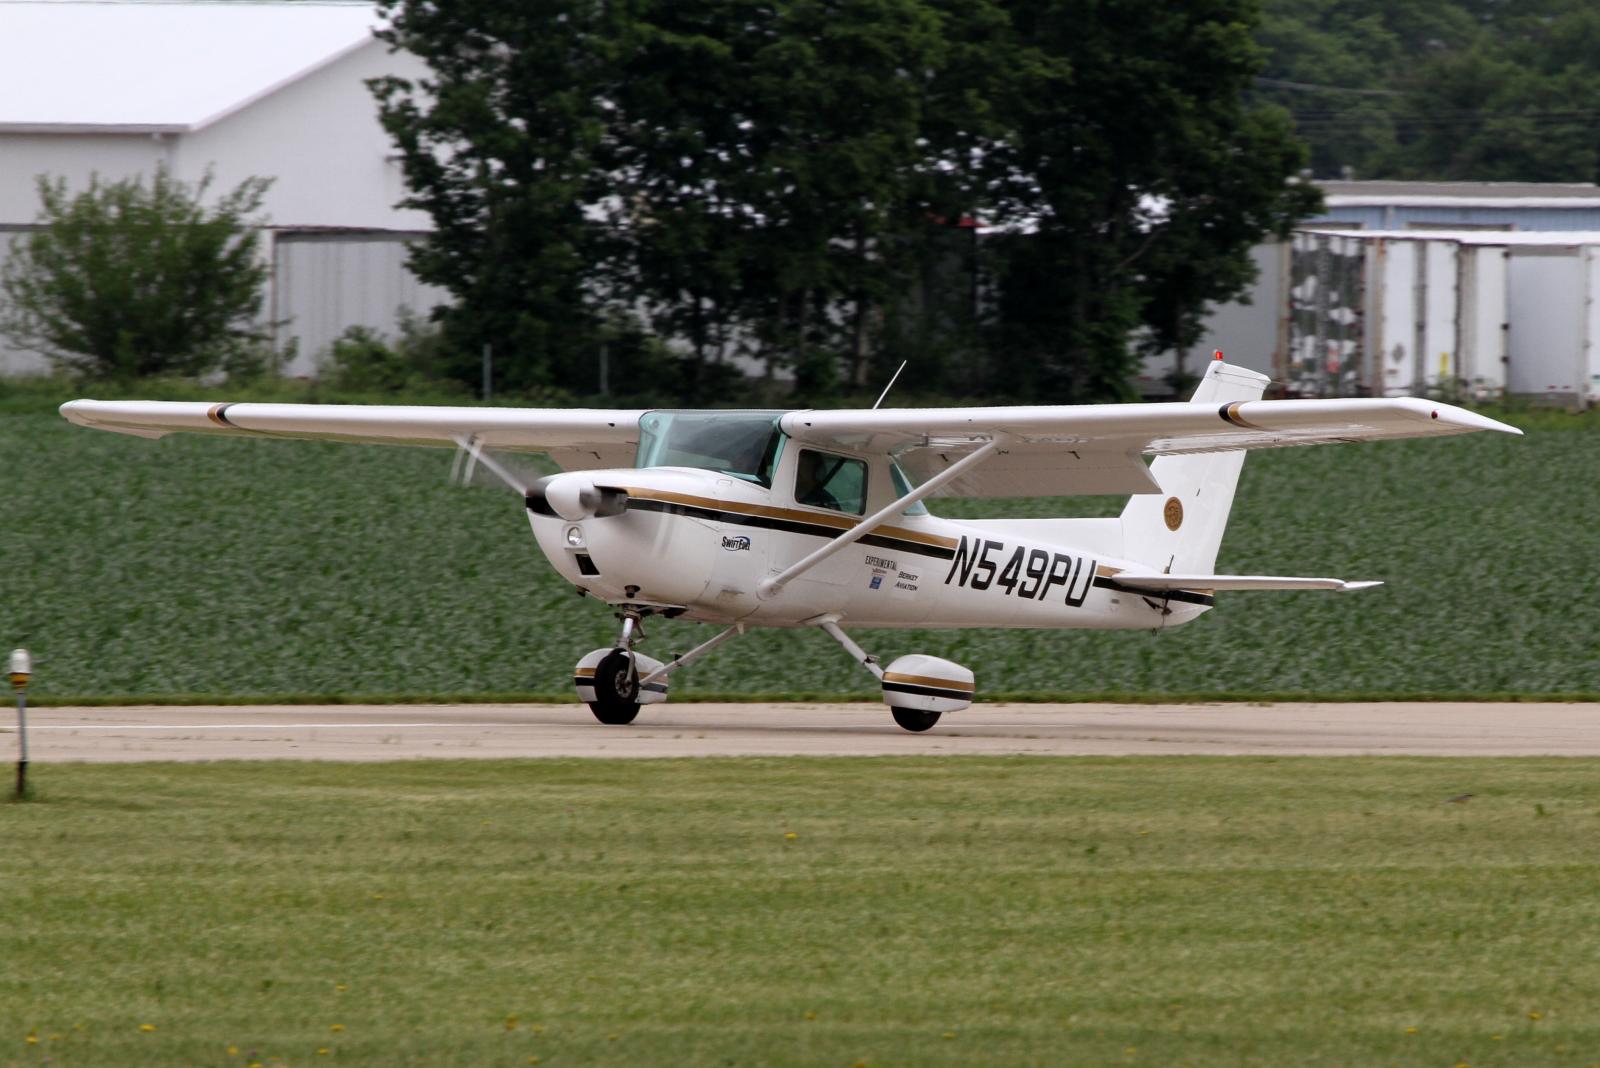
[1122,360,1272,574]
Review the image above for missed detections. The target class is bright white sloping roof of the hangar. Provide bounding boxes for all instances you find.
[0,0,378,133]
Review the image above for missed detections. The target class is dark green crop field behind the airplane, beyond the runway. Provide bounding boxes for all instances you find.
[0,406,1600,700]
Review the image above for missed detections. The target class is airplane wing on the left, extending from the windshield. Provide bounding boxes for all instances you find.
[61,400,645,470]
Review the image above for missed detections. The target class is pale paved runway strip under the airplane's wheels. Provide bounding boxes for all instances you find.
[0,703,1600,761]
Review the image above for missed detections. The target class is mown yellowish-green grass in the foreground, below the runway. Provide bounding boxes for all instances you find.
[0,758,1600,1068]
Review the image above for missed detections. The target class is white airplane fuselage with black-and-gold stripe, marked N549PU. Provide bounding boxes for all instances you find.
[528,467,1211,630]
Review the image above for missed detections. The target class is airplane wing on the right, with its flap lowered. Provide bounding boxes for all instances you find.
[781,390,1522,497]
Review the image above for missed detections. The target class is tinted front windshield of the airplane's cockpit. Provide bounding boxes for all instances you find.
[634,411,784,488]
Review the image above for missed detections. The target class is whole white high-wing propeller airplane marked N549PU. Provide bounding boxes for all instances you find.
[61,353,1522,731]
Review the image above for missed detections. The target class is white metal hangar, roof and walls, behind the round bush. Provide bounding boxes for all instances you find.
[0,0,445,373]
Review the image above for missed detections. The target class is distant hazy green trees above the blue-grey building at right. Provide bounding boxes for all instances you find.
[1253,0,1600,182]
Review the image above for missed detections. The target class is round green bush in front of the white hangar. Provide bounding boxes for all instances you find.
[0,168,270,377]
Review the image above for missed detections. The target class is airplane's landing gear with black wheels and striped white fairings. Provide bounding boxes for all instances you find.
[573,606,974,734]
